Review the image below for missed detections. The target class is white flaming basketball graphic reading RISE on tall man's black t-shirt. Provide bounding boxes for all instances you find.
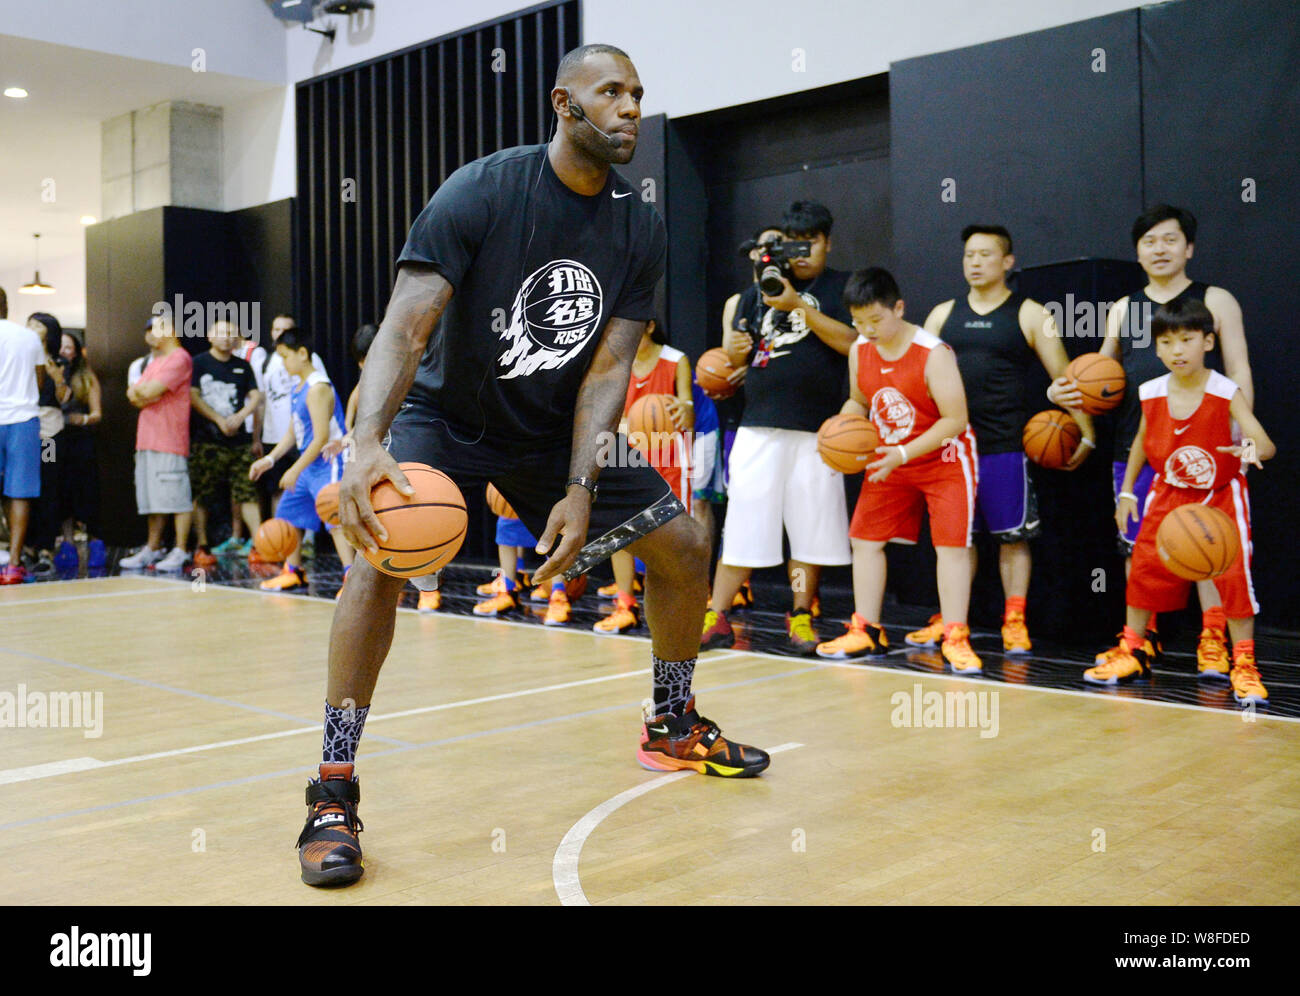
[497,259,603,380]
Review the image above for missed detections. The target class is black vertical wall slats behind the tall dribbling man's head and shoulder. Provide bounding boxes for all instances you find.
[300,0,579,391]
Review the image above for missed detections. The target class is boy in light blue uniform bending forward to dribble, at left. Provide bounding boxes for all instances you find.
[248,326,352,592]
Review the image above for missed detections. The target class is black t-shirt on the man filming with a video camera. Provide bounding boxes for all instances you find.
[736,269,853,432]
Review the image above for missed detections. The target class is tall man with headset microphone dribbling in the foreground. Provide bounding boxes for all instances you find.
[298,46,768,885]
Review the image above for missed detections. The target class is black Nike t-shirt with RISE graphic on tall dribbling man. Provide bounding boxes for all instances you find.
[398,146,667,443]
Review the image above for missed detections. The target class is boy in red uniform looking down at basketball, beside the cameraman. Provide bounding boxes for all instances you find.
[816,267,983,674]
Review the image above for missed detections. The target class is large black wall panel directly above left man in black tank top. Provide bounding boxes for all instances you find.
[889,10,1141,321]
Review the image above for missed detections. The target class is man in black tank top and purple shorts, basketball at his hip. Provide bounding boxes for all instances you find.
[907,225,1096,663]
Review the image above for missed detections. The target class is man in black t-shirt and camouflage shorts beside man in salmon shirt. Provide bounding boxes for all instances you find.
[190,321,261,549]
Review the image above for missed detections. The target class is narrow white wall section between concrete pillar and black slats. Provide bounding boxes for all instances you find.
[221,86,298,211]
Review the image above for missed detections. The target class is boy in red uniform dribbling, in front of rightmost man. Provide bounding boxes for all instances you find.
[1083,299,1277,705]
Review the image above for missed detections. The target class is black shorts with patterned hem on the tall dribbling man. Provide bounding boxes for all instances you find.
[384,399,685,580]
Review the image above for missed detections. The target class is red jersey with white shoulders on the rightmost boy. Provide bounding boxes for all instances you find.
[1138,371,1242,491]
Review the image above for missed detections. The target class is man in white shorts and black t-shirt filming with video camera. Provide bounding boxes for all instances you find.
[699,200,857,654]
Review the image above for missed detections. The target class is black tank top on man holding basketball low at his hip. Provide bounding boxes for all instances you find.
[939,294,1039,456]
